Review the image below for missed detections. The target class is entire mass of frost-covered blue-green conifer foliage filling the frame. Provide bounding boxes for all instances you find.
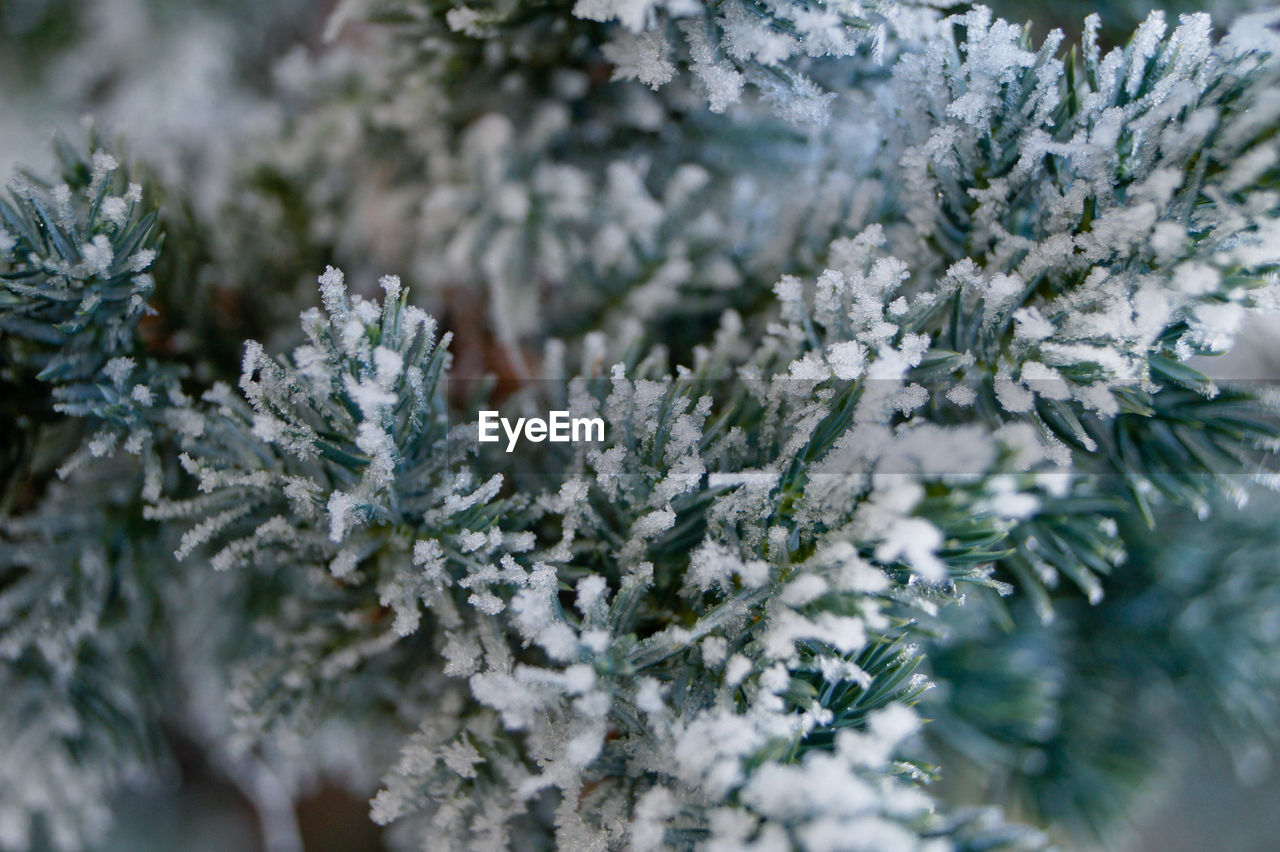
[0,1,1280,852]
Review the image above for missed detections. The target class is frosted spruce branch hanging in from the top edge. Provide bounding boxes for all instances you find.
[328,0,938,125]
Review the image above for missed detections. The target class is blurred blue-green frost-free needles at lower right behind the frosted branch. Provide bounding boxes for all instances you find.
[925,488,1276,842]
